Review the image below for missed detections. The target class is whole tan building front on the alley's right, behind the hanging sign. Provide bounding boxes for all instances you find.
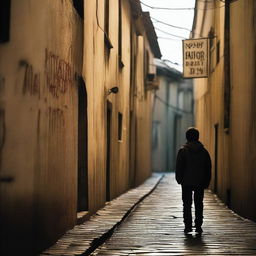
[192,0,256,221]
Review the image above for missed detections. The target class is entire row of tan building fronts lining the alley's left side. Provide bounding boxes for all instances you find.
[0,0,161,254]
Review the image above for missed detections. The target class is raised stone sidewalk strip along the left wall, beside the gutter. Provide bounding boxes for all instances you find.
[40,174,163,255]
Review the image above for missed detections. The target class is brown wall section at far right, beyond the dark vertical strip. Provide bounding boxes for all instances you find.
[230,0,256,221]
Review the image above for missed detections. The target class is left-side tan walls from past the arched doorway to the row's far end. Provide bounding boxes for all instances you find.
[83,0,156,208]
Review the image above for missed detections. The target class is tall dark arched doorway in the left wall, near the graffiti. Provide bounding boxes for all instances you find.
[77,76,88,212]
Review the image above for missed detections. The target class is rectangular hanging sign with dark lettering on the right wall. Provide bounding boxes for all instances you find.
[183,38,208,78]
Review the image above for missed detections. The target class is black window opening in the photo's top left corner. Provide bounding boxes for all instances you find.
[0,0,11,43]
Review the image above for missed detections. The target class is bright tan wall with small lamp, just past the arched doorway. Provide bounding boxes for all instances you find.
[83,1,134,211]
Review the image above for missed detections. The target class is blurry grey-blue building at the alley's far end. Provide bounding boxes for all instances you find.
[152,59,194,172]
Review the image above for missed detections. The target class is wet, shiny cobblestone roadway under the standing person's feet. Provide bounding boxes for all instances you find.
[91,174,256,256]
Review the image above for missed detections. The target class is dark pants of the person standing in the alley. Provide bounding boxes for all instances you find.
[182,185,204,228]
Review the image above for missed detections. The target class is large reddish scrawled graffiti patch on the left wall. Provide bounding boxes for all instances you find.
[45,49,74,98]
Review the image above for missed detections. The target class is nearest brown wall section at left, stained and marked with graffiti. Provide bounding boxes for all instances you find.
[0,0,82,253]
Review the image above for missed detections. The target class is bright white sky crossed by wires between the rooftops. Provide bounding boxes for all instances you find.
[141,0,195,72]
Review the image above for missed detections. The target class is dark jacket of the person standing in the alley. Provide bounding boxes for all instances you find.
[175,141,211,188]
